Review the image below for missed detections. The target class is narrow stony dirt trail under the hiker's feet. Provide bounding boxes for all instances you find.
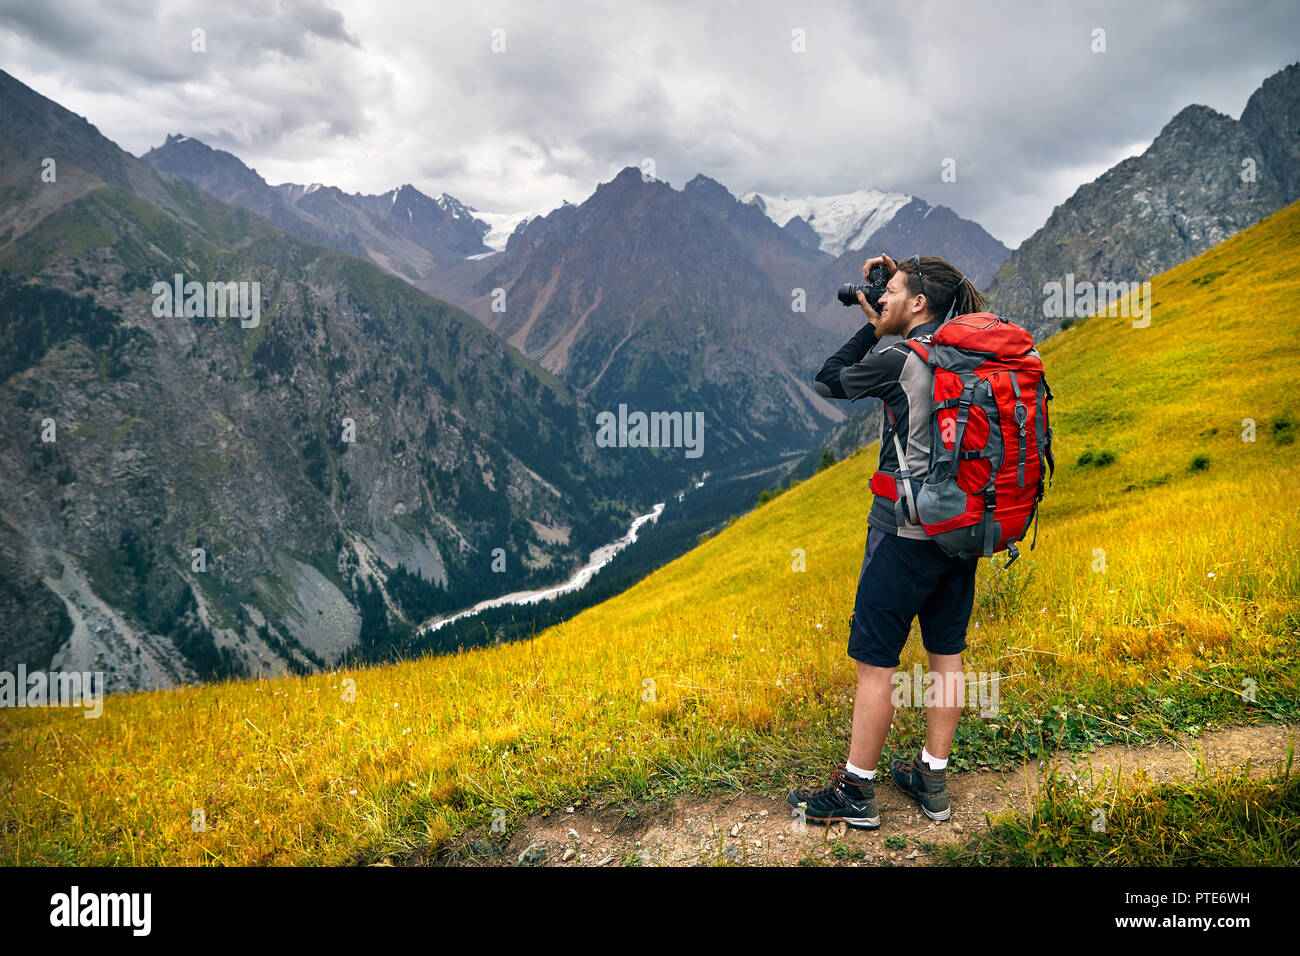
[454,724,1297,866]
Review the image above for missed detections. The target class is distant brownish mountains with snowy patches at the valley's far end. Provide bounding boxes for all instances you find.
[142,134,1009,458]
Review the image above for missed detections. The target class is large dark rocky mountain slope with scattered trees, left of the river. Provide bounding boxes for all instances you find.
[0,73,691,689]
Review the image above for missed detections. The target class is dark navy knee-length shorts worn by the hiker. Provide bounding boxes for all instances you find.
[849,525,978,667]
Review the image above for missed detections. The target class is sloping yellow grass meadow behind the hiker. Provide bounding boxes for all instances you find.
[0,204,1300,865]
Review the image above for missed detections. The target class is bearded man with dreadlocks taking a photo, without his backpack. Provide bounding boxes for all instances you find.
[788,255,985,830]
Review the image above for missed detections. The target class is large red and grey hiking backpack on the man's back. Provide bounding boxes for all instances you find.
[871,312,1056,568]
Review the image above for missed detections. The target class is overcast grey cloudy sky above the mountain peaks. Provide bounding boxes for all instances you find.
[0,0,1300,247]
